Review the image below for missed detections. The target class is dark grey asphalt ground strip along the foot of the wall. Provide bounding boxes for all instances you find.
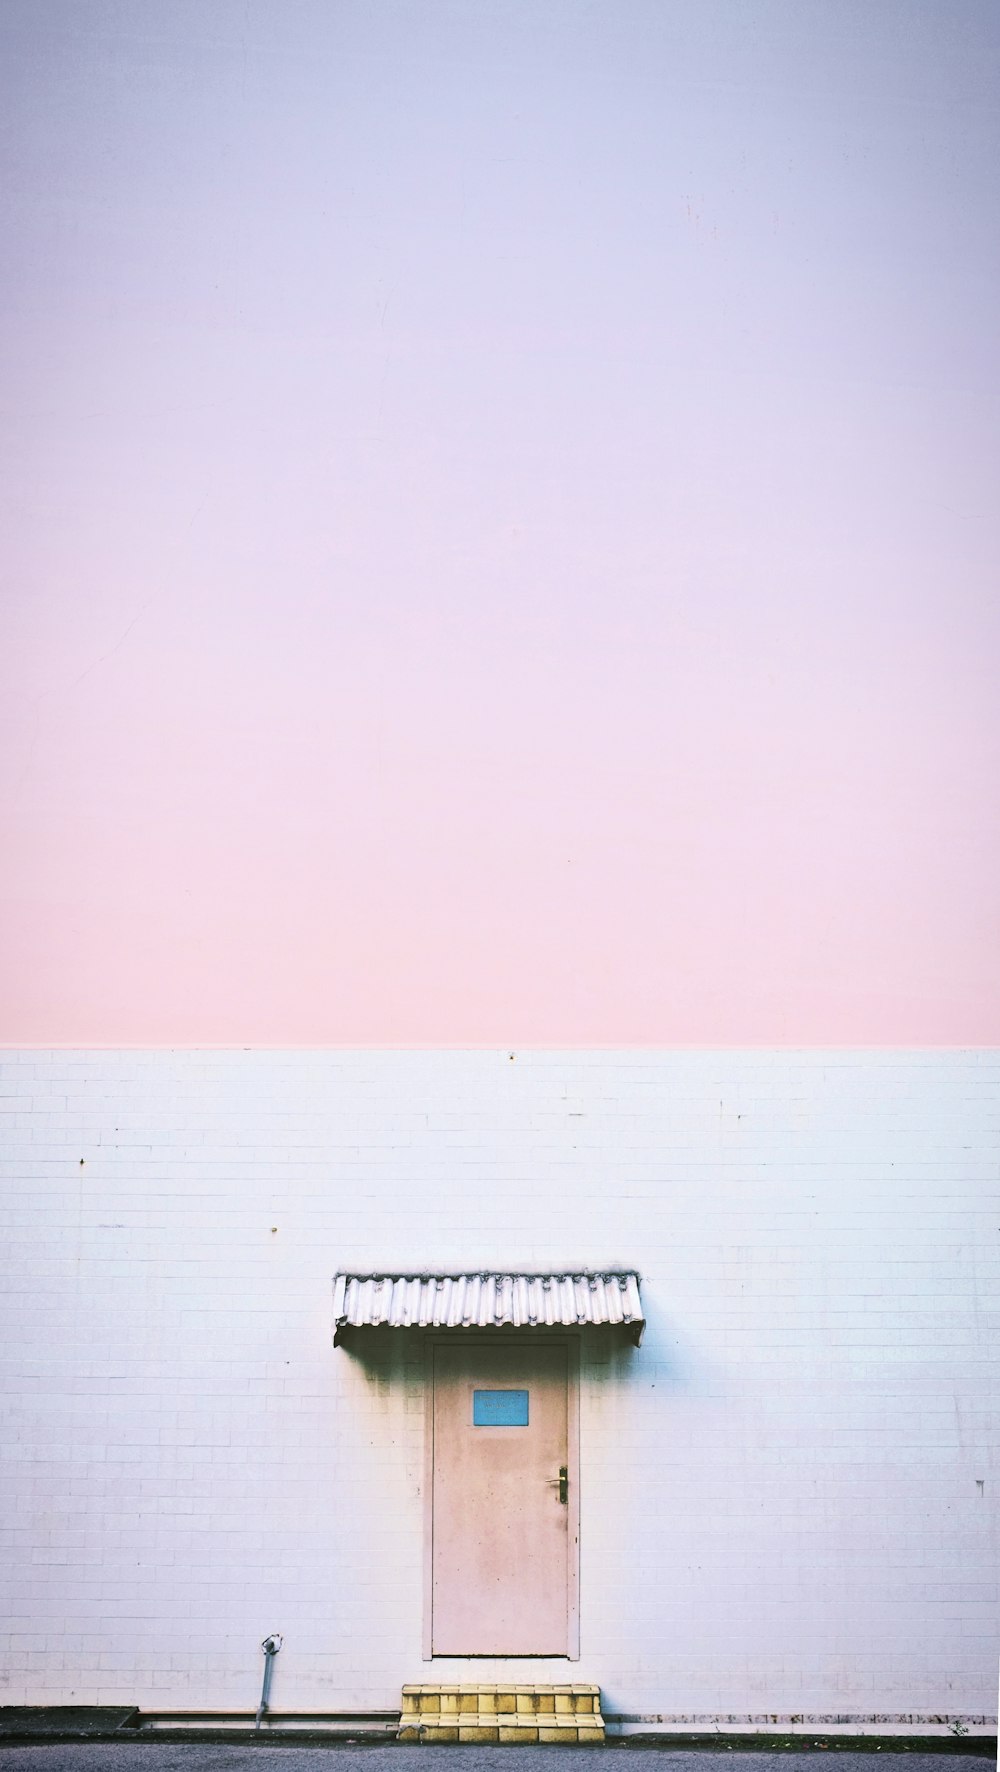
[0,1740,977,1772]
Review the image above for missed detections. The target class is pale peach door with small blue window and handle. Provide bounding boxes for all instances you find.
[431,1338,576,1655]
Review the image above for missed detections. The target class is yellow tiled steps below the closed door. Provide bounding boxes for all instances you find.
[399,1682,605,1745]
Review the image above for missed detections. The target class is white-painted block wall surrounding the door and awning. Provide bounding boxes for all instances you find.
[0,1051,1000,1717]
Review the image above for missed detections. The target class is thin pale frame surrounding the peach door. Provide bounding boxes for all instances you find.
[422,1329,580,1660]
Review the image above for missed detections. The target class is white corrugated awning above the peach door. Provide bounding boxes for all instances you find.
[333,1271,645,1347]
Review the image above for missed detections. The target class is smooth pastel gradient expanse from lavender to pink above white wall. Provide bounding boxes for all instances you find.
[0,0,1000,1044]
